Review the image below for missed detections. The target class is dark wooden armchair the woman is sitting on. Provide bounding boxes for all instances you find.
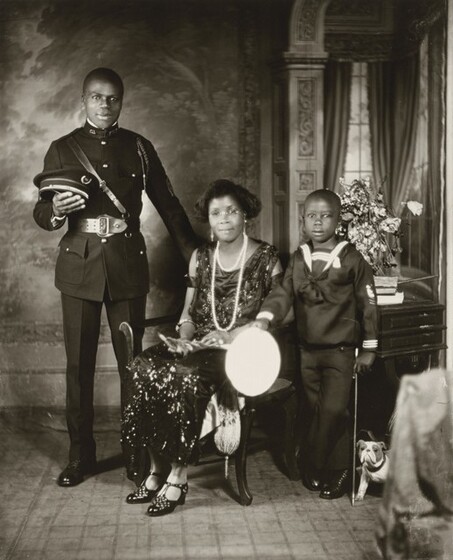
[120,315,300,506]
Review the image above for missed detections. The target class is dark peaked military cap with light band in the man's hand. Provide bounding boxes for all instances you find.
[33,168,99,200]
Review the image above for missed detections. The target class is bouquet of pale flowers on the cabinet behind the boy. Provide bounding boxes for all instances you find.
[337,178,423,276]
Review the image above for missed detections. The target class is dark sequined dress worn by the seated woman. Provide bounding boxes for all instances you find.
[122,242,278,479]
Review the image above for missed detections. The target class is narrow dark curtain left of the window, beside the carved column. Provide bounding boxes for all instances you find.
[324,60,352,191]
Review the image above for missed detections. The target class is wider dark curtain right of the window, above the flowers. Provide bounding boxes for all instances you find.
[368,53,419,216]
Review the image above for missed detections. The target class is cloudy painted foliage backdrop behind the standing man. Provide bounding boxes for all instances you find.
[0,0,261,406]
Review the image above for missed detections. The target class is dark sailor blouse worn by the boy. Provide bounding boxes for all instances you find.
[258,243,378,350]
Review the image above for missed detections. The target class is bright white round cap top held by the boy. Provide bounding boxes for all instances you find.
[225,327,281,397]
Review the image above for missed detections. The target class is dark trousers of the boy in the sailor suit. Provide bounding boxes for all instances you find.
[300,346,355,470]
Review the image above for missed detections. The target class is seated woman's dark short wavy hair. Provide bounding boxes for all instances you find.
[194,179,261,222]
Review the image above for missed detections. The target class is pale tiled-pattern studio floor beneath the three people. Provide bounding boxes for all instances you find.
[0,411,380,560]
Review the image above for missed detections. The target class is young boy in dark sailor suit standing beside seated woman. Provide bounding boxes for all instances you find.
[253,189,377,500]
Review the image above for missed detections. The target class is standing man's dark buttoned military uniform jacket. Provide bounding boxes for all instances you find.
[33,122,197,301]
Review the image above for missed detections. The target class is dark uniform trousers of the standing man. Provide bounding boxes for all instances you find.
[61,290,146,464]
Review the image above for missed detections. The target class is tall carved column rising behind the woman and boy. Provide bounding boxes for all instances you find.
[272,0,329,254]
